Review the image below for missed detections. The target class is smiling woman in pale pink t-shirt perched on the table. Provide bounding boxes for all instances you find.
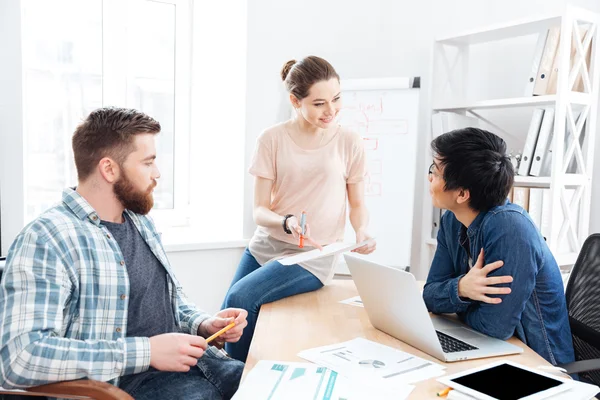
[223,56,376,361]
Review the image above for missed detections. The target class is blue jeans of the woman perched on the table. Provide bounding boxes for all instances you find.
[222,249,323,362]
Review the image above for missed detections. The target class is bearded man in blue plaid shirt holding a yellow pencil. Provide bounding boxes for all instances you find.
[0,108,248,400]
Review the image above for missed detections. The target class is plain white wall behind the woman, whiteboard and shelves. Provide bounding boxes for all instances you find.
[244,0,600,277]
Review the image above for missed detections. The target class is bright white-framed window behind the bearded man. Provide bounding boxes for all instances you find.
[22,0,190,224]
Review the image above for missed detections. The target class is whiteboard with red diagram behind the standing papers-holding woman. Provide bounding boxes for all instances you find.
[336,78,426,273]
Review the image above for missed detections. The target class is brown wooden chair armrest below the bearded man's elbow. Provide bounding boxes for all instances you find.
[0,379,134,400]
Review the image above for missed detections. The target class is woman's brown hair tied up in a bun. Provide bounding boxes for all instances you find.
[281,56,340,100]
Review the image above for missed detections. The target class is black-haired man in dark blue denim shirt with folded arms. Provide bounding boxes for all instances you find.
[423,128,574,365]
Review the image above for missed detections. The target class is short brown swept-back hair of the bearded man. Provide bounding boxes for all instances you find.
[73,107,160,181]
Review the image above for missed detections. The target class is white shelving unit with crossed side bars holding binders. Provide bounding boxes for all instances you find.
[421,6,600,271]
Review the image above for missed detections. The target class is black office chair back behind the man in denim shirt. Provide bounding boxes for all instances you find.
[560,233,600,386]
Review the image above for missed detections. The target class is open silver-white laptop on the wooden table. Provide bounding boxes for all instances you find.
[344,254,523,362]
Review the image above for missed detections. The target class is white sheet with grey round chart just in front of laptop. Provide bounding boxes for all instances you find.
[298,338,446,390]
